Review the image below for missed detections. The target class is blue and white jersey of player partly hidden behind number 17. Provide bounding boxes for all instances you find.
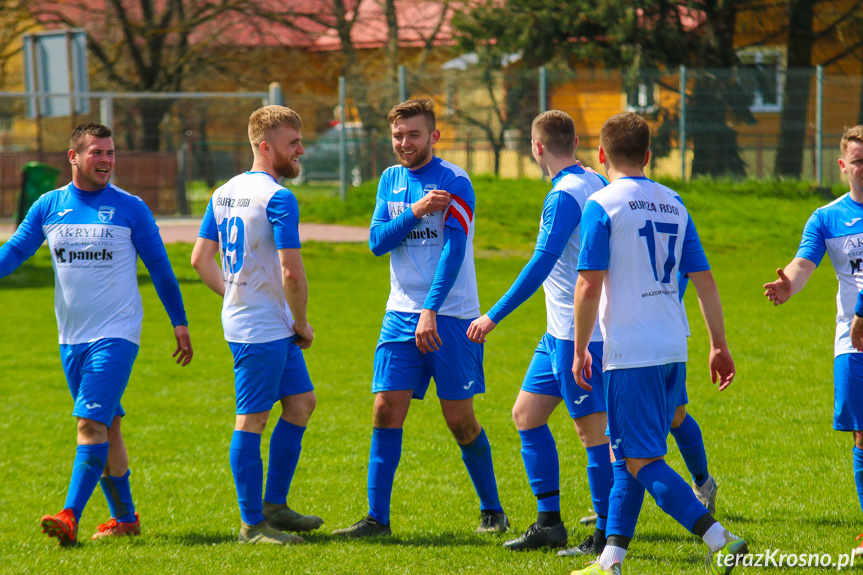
[536,166,606,341]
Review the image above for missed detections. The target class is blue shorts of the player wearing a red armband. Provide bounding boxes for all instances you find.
[372,315,485,400]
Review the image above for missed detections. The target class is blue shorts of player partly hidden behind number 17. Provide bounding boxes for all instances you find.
[521,333,605,419]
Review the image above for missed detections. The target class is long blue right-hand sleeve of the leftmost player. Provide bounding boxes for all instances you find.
[132,202,189,327]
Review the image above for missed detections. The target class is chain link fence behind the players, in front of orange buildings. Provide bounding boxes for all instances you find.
[0,65,863,217]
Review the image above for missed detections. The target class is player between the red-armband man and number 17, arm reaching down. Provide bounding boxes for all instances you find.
[467,110,612,555]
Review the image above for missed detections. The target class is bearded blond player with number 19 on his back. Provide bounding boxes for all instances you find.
[192,106,324,545]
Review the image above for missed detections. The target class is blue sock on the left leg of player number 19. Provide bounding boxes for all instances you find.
[231,430,264,525]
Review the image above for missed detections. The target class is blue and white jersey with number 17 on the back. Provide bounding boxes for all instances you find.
[578,178,710,370]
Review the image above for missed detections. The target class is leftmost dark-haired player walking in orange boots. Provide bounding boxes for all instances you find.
[0,122,193,545]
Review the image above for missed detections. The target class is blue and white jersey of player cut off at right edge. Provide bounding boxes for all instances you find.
[797,193,863,355]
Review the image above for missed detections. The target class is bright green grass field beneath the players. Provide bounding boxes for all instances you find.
[0,179,863,575]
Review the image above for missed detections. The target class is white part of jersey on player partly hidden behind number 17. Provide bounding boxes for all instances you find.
[540,170,605,341]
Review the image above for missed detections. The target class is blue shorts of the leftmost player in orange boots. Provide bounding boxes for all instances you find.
[60,338,138,427]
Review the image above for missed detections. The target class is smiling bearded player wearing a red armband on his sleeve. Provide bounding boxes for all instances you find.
[334,99,509,537]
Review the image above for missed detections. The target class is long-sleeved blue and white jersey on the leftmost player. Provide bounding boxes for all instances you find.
[0,184,186,345]
